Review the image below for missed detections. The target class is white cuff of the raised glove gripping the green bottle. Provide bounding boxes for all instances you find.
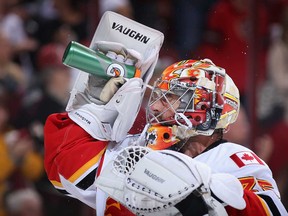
[68,78,143,142]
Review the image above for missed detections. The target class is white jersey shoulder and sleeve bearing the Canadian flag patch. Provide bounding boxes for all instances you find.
[194,142,288,215]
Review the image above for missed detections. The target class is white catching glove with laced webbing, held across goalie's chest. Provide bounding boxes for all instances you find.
[96,146,245,215]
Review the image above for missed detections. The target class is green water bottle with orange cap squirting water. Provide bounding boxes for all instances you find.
[62,41,140,79]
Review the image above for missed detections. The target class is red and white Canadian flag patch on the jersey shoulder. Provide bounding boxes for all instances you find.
[230,151,264,168]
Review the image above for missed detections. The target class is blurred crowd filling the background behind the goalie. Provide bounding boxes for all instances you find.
[0,0,288,216]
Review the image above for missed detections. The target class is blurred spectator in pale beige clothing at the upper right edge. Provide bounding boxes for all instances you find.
[258,5,288,128]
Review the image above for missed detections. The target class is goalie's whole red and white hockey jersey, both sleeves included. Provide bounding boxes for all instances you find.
[44,113,288,216]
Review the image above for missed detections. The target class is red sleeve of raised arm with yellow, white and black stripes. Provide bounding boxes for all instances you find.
[44,113,108,191]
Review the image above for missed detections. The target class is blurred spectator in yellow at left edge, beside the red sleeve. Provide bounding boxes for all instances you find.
[0,100,43,216]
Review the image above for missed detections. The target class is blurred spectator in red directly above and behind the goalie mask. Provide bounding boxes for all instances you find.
[199,0,268,106]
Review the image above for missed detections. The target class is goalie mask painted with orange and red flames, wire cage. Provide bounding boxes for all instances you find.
[146,59,240,150]
